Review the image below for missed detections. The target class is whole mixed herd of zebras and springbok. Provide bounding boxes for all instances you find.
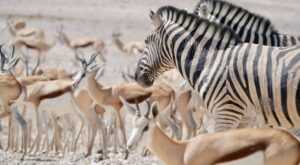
[0,0,300,165]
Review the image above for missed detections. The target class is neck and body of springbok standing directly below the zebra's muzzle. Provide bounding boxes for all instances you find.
[87,69,180,155]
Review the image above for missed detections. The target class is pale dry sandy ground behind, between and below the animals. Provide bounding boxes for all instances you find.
[0,0,300,165]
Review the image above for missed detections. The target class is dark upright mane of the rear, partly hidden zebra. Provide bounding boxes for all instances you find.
[193,0,278,32]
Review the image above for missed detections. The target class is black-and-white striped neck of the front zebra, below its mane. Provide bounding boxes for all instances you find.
[167,22,239,87]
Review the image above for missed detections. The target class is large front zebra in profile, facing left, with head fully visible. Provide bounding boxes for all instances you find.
[135,6,300,132]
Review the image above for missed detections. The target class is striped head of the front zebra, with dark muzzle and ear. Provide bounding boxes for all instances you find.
[135,11,174,87]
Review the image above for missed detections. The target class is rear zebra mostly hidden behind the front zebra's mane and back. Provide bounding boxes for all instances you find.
[194,0,300,47]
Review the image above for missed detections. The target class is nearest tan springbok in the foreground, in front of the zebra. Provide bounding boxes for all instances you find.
[127,103,300,165]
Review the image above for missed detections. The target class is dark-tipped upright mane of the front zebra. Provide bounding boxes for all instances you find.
[156,6,241,43]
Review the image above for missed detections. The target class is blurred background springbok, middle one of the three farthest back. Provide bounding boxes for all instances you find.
[58,27,106,62]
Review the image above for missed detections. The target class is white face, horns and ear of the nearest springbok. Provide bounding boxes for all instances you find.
[120,98,158,150]
